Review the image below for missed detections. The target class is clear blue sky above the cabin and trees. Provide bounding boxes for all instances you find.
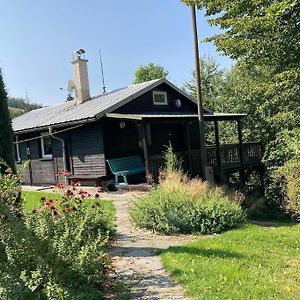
[0,0,232,105]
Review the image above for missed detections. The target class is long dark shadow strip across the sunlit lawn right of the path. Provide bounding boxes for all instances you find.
[162,246,247,259]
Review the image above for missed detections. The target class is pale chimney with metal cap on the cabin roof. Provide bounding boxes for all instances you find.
[72,49,91,104]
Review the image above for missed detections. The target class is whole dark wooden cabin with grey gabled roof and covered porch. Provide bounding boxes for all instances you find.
[13,79,262,185]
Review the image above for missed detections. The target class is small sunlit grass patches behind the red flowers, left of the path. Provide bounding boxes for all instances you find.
[22,192,115,223]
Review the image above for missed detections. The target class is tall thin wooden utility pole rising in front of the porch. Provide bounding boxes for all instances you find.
[191,4,207,179]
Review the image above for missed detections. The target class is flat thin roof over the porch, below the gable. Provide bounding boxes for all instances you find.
[106,113,247,121]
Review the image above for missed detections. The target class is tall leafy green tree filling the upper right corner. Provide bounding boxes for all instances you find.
[183,0,300,140]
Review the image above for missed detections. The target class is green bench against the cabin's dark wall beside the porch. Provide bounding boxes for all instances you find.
[106,155,145,184]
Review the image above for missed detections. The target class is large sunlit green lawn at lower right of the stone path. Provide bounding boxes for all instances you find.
[161,225,300,300]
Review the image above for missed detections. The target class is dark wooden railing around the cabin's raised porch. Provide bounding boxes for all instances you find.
[148,142,262,179]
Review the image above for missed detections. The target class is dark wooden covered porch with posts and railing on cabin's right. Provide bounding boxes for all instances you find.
[107,113,262,182]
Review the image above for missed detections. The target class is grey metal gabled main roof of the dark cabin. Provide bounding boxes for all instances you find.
[12,78,212,133]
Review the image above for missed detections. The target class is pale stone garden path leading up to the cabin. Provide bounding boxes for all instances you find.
[101,193,199,300]
